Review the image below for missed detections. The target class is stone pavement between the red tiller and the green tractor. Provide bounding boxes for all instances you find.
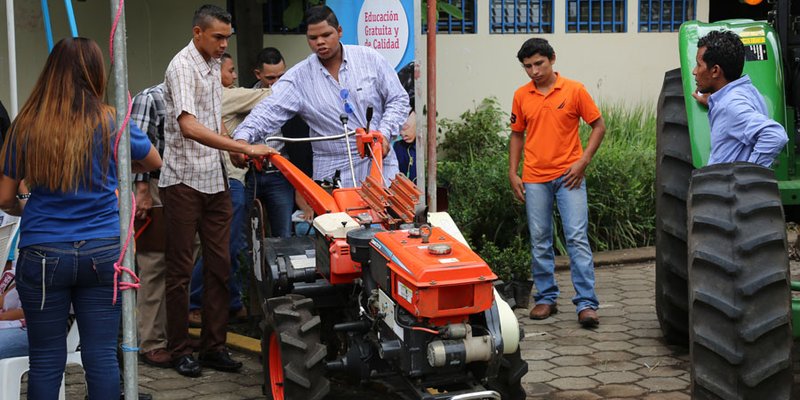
[517,263,689,400]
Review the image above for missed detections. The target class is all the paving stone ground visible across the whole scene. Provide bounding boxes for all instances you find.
[50,263,800,400]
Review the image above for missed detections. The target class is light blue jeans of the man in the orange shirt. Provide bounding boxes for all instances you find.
[525,176,599,312]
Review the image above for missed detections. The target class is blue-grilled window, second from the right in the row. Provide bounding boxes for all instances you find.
[567,0,627,33]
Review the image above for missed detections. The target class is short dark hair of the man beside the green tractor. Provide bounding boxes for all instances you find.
[697,31,744,82]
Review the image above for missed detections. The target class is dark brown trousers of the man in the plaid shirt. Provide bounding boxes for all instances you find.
[160,184,233,359]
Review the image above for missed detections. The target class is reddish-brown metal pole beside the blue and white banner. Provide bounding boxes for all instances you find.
[426,0,439,212]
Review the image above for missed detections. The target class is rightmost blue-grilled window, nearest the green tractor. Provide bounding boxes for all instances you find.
[639,0,696,32]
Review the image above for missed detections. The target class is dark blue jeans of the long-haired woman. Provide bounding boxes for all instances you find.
[16,238,122,400]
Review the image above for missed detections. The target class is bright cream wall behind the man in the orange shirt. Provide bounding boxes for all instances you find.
[437,0,708,117]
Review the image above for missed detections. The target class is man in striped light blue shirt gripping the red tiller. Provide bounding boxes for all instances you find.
[233,6,409,187]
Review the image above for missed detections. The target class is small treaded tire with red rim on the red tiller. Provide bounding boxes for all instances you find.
[261,294,330,400]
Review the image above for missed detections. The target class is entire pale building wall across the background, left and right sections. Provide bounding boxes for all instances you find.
[0,0,708,117]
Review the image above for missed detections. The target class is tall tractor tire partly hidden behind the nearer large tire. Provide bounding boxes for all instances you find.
[655,69,694,345]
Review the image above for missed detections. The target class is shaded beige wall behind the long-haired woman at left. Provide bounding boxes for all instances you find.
[0,0,231,115]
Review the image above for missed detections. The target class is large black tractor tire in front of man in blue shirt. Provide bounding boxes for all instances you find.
[688,163,793,400]
